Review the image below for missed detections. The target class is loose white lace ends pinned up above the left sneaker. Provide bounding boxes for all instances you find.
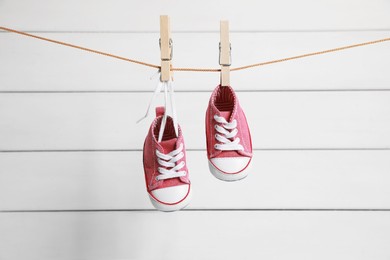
[137,72,179,142]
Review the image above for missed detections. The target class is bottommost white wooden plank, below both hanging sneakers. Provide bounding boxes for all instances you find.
[0,211,390,260]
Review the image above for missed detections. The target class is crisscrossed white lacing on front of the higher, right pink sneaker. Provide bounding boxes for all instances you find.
[214,115,244,151]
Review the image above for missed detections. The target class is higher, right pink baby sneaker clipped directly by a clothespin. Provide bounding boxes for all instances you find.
[206,85,252,181]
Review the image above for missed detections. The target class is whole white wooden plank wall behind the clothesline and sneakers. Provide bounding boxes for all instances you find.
[0,0,390,260]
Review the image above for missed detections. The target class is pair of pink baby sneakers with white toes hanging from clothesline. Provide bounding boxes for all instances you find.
[143,86,252,211]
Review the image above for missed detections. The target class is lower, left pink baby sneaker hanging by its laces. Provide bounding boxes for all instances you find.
[143,107,191,211]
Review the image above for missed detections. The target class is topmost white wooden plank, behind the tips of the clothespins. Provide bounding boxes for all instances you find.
[0,0,390,31]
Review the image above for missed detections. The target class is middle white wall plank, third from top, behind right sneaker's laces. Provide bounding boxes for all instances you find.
[0,91,390,150]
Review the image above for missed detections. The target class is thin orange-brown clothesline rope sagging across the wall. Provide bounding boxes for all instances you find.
[0,26,390,72]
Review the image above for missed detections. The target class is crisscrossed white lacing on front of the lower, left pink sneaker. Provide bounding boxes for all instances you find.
[156,144,186,181]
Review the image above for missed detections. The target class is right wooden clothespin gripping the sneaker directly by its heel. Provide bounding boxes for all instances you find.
[219,21,232,87]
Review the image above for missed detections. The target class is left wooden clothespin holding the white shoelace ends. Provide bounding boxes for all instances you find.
[160,15,173,81]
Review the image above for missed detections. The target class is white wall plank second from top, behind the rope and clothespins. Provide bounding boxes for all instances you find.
[0,31,390,91]
